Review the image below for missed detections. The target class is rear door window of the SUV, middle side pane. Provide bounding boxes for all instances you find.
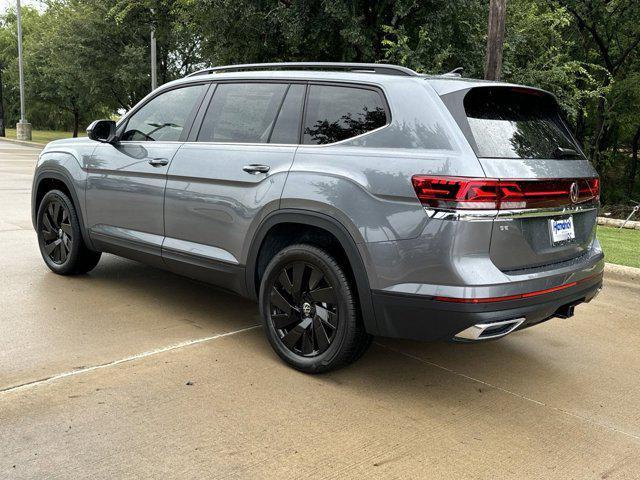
[198,83,287,143]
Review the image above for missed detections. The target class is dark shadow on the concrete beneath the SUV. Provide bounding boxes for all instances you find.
[82,255,562,404]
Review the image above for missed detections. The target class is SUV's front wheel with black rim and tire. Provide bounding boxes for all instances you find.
[36,190,102,275]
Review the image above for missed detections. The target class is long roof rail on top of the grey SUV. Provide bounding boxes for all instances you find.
[187,62,420,77]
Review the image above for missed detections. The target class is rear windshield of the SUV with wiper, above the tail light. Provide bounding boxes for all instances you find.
[464,87,583,159]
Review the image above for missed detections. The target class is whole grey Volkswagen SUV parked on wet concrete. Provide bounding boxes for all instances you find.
[32,63,604,372]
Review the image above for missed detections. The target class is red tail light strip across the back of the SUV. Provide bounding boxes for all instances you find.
[411,175,600,210]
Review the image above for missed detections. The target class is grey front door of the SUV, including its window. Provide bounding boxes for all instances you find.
[85,83,209,263]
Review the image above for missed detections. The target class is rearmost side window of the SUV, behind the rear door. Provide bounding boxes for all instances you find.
[303,85,387,144]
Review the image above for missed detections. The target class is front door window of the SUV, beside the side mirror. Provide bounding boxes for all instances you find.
[121,85,207,142]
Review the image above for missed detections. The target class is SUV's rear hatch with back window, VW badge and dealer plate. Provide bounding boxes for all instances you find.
[443,85,599,273]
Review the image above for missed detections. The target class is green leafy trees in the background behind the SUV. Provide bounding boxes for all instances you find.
[0,0,640,202]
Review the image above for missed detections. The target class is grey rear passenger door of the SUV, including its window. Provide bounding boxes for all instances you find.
[162,82,306,292]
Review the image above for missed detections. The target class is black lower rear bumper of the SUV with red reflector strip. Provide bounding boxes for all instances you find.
[372,270,602,340]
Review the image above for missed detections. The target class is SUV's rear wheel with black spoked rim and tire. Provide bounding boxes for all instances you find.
[259,244,372,373]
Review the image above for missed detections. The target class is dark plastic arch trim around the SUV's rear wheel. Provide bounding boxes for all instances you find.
[245,209,378,335]
